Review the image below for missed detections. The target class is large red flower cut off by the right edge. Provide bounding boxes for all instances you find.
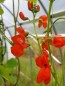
[51,35,65,48]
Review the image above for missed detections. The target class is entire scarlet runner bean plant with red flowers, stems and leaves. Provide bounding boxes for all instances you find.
[0,0,65,86]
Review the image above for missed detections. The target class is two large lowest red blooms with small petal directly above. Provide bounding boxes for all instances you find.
[35,49,51,84]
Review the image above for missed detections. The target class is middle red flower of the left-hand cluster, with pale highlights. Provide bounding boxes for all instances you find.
[11,35,28,48]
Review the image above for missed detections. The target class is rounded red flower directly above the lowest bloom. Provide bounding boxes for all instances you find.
[35,55,49,68]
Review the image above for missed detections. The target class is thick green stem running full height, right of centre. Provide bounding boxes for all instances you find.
[47,0,60,86]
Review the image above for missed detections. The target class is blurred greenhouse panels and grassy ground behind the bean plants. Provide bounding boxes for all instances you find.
[0,0,65,86]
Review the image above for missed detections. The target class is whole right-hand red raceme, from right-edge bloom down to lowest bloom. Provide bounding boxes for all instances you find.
[36,35,65,84]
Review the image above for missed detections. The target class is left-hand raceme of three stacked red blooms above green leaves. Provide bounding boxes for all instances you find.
[11,27,28,57]
